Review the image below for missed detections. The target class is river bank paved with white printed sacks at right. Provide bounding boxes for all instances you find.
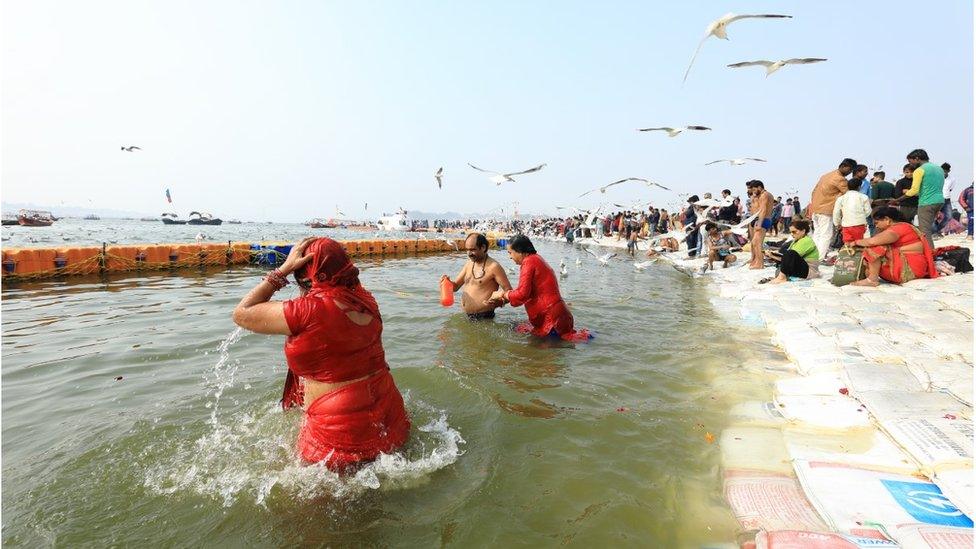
[711,239,976,548]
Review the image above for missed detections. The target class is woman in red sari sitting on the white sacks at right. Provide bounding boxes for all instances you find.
[851,203,939,286]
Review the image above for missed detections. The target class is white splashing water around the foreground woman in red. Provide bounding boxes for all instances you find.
[144,328,465,507]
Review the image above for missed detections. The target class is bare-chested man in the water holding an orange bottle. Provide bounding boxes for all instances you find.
[441,233,512,320]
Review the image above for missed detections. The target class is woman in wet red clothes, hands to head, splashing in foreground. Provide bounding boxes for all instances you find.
[234,237,410,470]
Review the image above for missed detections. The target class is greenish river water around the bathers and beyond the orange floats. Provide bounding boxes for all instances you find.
[2,221,784,547]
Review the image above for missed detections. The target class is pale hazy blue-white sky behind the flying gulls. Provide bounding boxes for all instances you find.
[0,0,973,221]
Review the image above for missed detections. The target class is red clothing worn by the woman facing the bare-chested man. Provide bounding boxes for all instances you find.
[508,254,585,339]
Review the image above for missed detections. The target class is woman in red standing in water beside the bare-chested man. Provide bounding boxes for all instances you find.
[489,235,589,341]
